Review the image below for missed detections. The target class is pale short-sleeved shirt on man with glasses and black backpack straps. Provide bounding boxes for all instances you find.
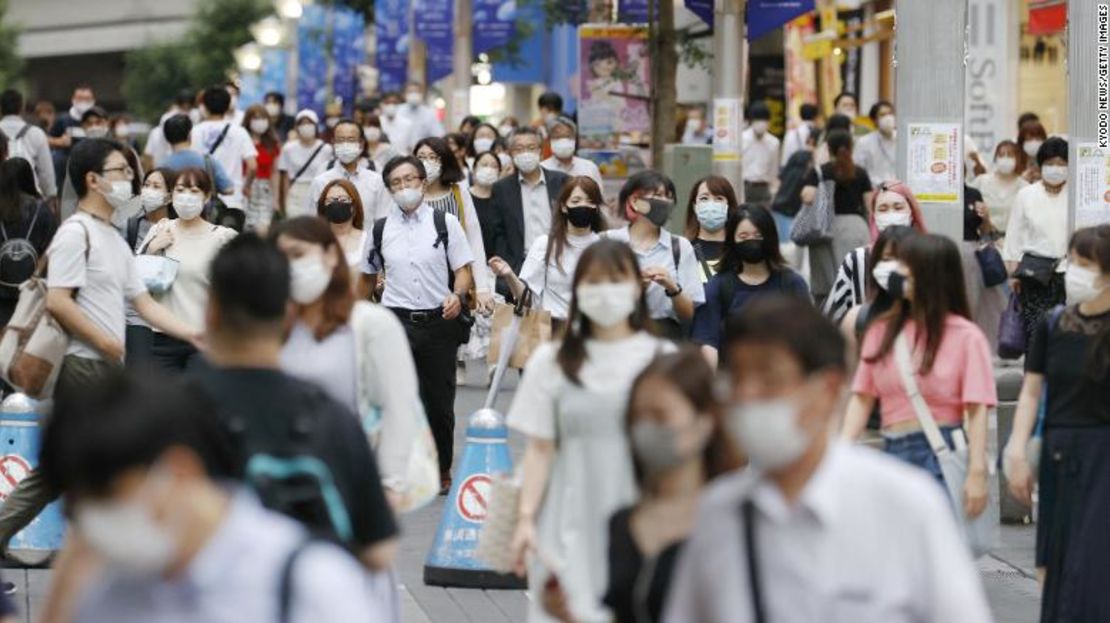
[362,204,474,310]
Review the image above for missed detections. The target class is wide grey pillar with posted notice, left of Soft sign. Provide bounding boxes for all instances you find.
[895,0,963,240]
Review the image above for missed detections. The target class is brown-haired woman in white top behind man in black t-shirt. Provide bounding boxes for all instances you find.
[271,217,426,510]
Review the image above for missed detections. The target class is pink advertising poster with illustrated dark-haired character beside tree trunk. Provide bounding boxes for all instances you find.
[578,24,652,137]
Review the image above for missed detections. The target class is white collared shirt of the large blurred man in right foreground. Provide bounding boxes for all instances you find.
[663,442,992,623]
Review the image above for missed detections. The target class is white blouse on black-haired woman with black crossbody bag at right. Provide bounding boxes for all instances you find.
[1002,182,1068,266]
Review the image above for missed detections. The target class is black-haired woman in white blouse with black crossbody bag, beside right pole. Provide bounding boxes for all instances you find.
[1002,137,1068,346]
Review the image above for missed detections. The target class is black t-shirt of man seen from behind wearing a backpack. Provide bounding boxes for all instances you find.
[192,363,397,551]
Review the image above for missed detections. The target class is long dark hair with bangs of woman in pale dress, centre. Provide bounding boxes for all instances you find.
[556,238,650,385]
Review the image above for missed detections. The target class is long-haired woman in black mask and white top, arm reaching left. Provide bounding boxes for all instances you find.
[490,175,605,335]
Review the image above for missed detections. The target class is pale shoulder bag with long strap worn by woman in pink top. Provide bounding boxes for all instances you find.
[895,334,999,557]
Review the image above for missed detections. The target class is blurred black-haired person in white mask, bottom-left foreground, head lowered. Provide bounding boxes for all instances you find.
[35,373,380,623]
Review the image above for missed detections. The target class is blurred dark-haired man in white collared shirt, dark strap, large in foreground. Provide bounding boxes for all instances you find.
[664,297,991,623]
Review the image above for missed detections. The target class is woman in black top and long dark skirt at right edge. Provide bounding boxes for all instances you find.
[1002,225,1110,621]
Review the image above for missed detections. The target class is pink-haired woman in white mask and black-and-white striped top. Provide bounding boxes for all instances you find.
[823,180,925,323]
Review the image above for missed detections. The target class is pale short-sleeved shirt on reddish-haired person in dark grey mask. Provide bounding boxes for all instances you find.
[602,228,705,320]
